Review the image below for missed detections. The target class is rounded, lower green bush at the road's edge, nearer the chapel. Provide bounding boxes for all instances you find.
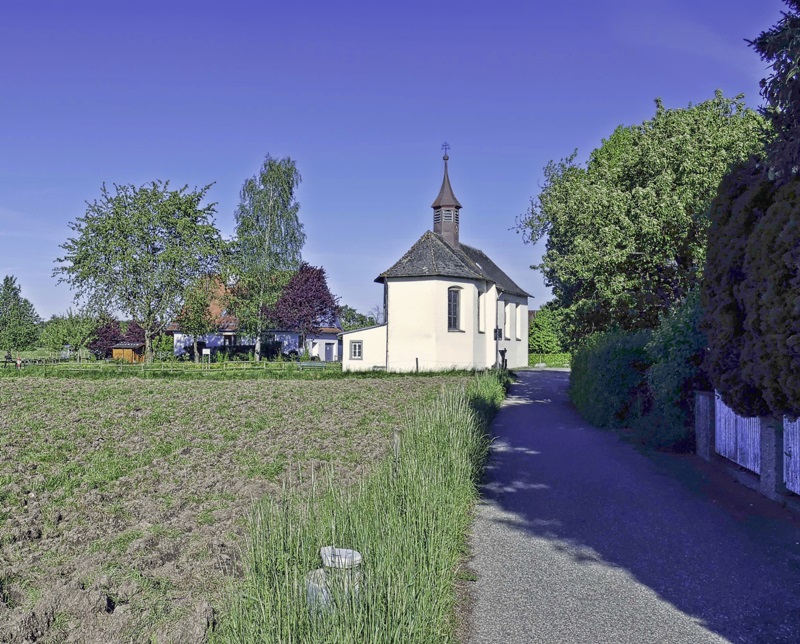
[569,330,652,427]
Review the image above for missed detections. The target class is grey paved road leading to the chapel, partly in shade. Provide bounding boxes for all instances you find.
[467,371,800,644]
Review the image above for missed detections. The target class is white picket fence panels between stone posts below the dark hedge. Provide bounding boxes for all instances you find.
[714,394,800,494]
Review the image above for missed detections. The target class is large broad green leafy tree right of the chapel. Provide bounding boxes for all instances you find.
[518,92,763,344]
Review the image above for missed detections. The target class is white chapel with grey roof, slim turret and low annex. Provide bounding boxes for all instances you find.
[340,153,529,371]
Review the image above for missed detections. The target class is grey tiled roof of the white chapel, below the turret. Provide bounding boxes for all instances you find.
[375,230,529,297]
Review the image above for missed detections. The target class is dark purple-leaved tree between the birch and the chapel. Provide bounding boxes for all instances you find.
[272,263,338,335]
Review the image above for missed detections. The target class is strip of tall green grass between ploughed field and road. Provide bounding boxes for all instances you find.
[213,373,505,644]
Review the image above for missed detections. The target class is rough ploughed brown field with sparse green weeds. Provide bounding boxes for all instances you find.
[0,375,469,642]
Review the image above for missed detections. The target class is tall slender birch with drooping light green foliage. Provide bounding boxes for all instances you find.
[228,155,305,360]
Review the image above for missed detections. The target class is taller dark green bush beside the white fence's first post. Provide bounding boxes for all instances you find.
[632,289,711,451]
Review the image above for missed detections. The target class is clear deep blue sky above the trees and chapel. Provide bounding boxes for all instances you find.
[0,0,785,318]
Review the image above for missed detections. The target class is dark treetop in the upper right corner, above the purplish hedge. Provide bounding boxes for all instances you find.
[748,0,800,183]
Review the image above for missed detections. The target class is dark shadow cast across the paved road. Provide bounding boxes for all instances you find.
[482,371,800,643]
